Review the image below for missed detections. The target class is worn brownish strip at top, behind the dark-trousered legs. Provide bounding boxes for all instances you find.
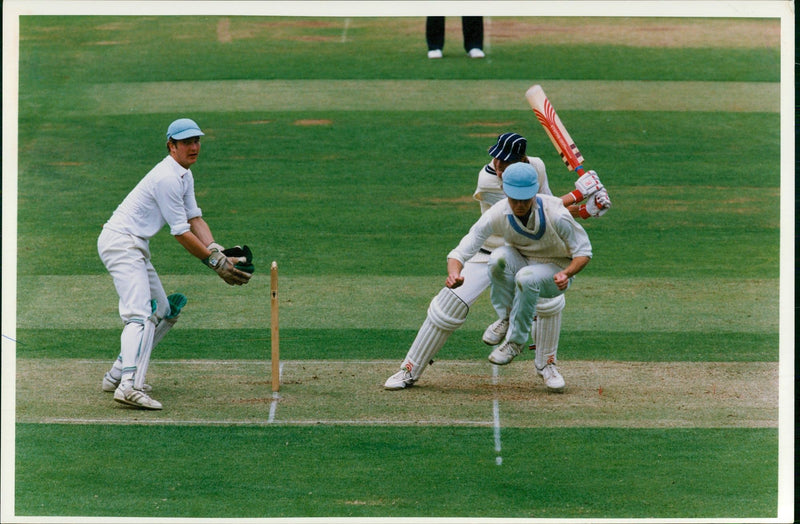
[205,16,780,48]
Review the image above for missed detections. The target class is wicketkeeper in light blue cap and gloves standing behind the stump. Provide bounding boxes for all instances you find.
[97,118,254,409]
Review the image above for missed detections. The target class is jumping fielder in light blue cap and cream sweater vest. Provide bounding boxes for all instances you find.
[445,162,592,365]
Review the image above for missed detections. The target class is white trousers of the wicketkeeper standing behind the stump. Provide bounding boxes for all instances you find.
[97,228,169,374]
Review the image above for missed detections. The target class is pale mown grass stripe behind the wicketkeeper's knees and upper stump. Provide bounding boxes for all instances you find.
[17,275,779,333]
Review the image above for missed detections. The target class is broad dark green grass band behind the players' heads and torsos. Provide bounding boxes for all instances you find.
[18,111,780,278]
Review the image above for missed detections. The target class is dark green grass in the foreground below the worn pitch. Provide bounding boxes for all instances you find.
[16,424,777,519]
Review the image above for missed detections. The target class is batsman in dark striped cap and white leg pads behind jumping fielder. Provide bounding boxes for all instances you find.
[384,133,611,392]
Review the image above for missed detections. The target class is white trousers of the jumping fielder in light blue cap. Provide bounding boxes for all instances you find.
[489,246,572,344]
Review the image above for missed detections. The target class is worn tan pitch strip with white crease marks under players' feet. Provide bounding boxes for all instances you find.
[16,355,778,428]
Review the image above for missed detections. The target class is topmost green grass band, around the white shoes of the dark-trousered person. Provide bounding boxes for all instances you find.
[20,16,780,90]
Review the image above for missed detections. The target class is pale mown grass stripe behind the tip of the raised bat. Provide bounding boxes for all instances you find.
[83,78,780,115]
